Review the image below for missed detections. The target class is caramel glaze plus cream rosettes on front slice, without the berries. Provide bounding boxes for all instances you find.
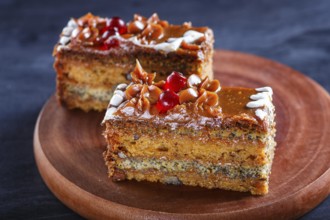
[105,61,271,132]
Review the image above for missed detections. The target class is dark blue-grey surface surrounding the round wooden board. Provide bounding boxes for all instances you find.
[0,0,330,219]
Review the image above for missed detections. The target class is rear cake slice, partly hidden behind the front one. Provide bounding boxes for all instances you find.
[53,13,213,111]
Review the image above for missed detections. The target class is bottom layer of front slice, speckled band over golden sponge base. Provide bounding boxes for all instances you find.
[104,154,271,195]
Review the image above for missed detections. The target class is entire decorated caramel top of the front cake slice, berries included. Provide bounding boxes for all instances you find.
[103,61,274,131]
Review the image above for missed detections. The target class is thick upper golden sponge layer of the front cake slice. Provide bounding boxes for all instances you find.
[105,121,275,166]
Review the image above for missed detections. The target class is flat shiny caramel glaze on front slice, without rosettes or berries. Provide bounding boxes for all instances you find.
[112,87,271,133]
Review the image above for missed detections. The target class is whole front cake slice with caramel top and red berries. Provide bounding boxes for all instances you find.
[103,61,276,195]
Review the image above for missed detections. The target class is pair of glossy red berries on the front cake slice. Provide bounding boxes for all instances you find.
[156,72,187,113]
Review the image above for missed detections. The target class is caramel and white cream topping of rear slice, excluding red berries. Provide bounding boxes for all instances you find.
[57,13,208,53]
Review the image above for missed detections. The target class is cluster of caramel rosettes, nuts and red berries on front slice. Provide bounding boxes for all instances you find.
[110,61,221,117]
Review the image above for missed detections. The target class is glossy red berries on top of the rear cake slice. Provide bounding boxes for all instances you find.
[98,17,127,50]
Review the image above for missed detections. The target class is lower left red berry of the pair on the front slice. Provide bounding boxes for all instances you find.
[156,90,179,113]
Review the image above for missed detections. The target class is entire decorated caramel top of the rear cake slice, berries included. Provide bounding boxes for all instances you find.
[54,13,213,54]
